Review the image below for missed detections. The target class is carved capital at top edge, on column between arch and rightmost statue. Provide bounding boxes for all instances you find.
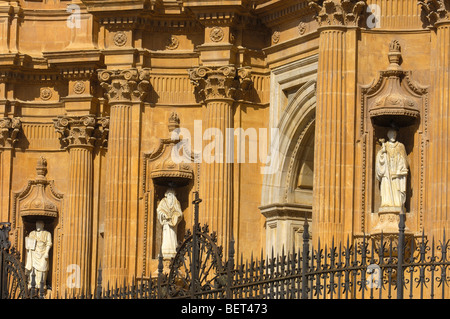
[309,0,366,26]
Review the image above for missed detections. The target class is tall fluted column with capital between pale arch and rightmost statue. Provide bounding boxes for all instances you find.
[310,0,365,242]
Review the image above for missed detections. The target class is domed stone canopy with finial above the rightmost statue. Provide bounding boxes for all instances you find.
[364,40,427,127]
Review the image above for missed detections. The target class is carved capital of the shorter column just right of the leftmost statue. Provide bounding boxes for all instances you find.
[54,115,109,148]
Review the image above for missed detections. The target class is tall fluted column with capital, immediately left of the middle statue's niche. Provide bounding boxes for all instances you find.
[98,69,150,282]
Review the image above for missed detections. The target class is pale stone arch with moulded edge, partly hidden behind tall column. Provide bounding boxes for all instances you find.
[259,81,316,253]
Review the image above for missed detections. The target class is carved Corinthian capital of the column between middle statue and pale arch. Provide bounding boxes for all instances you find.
[189,65,252,101]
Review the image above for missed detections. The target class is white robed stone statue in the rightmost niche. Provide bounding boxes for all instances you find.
[375,129,408,213]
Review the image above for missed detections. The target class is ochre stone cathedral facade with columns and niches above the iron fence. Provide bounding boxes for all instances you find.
[0,0,450,292]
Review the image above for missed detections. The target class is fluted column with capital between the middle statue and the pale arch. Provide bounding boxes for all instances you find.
[190,66,251,251]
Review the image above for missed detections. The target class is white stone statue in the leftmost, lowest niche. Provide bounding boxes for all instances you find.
[25,220,52,289]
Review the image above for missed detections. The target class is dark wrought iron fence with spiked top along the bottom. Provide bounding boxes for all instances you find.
[2,194,450,299]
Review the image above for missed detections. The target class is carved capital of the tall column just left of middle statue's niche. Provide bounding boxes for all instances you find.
[98,69,150,103]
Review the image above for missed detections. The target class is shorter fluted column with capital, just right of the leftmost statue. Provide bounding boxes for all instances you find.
[55,115,108,291]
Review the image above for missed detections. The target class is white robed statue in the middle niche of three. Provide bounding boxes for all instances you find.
[156,188,183,259]
